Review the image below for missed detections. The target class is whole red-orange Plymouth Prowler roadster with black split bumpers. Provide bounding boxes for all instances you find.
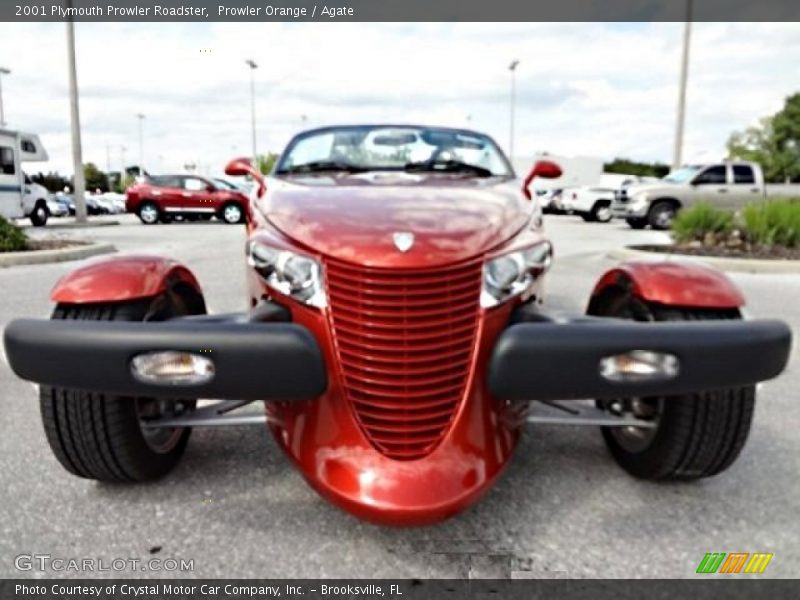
[5,125,791,525]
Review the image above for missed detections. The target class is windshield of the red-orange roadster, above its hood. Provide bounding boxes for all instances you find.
[276,126,513,177]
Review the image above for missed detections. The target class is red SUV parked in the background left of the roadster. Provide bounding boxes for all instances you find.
[125,175,248,225]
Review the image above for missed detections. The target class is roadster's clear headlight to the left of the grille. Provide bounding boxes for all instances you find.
[247,241,327,308]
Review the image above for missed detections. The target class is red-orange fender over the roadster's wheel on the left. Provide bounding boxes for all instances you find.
[50,256,203,304]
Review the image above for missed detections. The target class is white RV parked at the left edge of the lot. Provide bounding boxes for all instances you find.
[0,129,50,227]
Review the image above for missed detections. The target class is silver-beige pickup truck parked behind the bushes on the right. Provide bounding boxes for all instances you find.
[611,161,800,229]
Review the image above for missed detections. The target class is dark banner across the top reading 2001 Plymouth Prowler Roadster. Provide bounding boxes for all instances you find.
[0,0,800,22]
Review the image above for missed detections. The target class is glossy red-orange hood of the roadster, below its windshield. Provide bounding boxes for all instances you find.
[263,172,532,268]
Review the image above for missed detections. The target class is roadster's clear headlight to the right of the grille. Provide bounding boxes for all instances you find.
[481,242,553,308]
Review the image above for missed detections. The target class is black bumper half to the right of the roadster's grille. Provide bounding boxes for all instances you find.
[488,317,792,400]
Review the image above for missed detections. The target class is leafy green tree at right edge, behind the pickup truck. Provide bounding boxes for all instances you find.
[728,93,800,183]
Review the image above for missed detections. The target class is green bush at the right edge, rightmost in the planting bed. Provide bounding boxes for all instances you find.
[742,198,800,248]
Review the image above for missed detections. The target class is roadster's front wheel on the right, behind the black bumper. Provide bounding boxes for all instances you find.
[598,296,755,480]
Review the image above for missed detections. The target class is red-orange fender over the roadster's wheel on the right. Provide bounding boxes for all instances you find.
[588,261,745,314]
